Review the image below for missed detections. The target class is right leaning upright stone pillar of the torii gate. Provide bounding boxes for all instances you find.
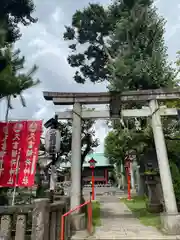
[150,100,178,214]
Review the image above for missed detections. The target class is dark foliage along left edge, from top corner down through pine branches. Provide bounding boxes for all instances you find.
[0,0,39,118]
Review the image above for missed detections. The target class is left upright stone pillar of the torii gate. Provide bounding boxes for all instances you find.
[71,103,81,209]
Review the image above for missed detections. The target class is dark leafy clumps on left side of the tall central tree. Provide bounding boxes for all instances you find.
[64,4,109,83]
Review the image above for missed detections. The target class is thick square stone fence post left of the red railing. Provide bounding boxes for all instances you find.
[31,198,49,240]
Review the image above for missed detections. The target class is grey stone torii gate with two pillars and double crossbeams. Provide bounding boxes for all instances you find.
[43,89,180,233]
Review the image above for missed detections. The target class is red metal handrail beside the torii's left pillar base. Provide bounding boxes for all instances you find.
[60,200,93,240]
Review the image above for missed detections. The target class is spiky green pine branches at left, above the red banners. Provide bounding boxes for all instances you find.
[0,45,40,121]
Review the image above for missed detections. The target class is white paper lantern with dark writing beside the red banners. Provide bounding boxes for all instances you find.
[45,129,61,155]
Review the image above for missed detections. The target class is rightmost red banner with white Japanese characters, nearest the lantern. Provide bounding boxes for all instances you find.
[17,121,42,187]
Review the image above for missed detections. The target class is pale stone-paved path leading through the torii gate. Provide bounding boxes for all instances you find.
[90,196,180,239]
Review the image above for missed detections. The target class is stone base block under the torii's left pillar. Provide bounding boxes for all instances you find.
[71,213,86,231]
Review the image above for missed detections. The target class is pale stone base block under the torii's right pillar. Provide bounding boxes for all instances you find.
[160,213,180,235]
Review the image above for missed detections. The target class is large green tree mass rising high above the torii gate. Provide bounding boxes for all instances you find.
[64,0,175,89]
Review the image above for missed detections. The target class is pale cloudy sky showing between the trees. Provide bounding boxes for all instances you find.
[0,0,180,152]
